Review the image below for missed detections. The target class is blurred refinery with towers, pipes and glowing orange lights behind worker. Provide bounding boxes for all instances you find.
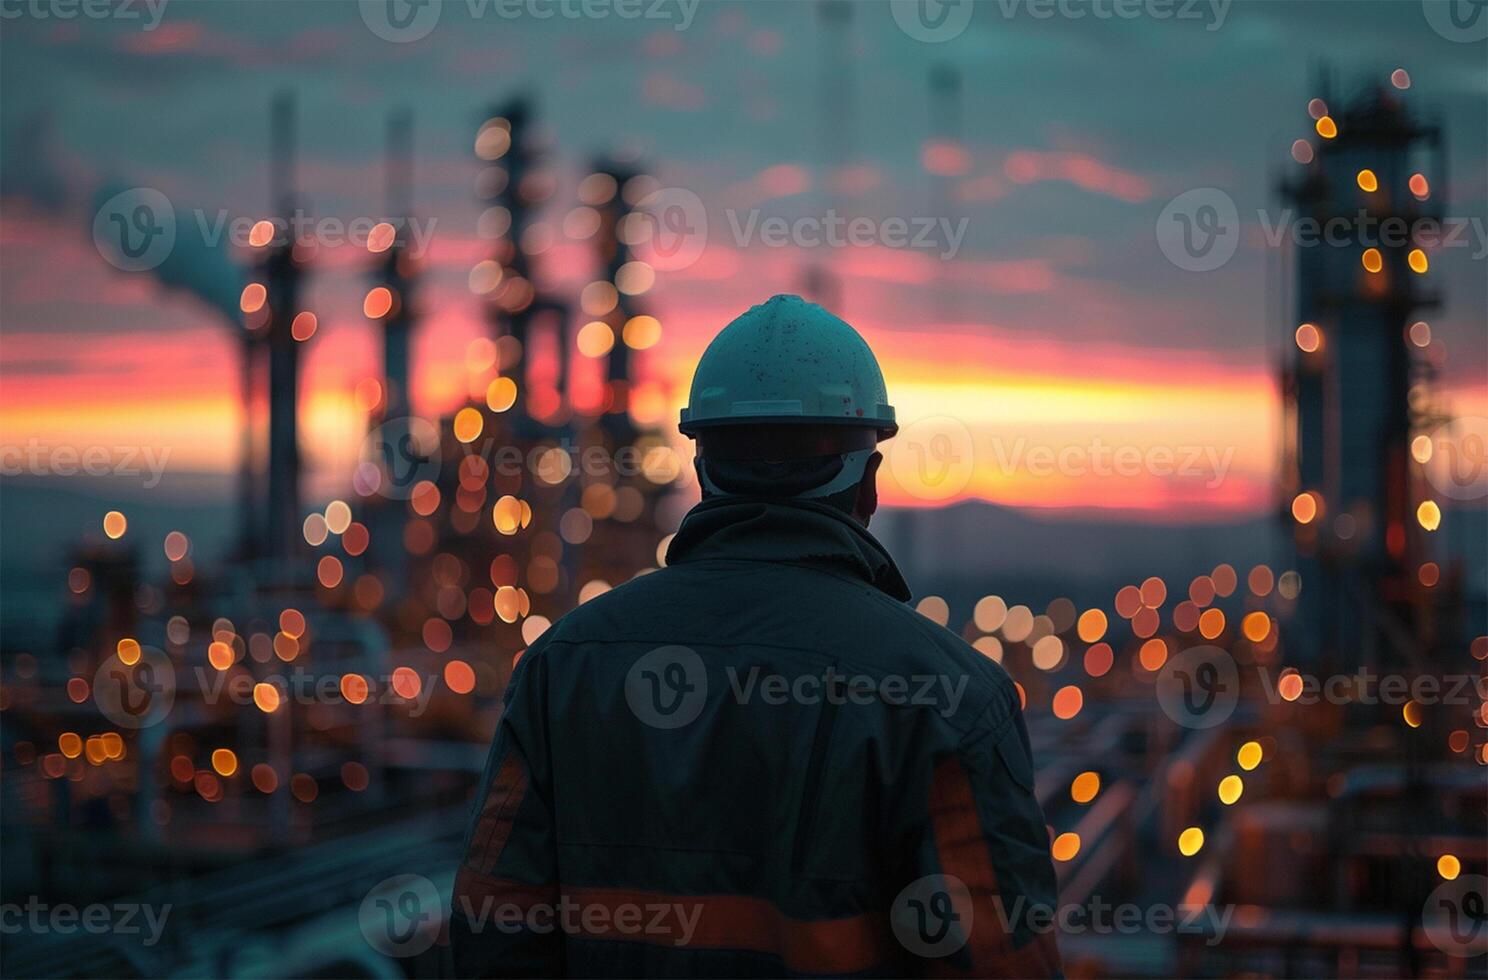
[0,49,1488,977]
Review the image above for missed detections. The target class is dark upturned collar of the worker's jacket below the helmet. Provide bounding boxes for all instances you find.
[667,498,909,602]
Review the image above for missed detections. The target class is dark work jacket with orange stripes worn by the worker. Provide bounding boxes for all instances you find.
[449,500,1059,977]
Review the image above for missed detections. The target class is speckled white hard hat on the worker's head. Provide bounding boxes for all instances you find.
[679,294,899,439]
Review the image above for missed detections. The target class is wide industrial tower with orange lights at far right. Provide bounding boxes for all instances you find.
[1281,73,1443,671]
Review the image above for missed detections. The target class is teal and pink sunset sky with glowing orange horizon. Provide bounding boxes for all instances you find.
[0,0,1488,520]
